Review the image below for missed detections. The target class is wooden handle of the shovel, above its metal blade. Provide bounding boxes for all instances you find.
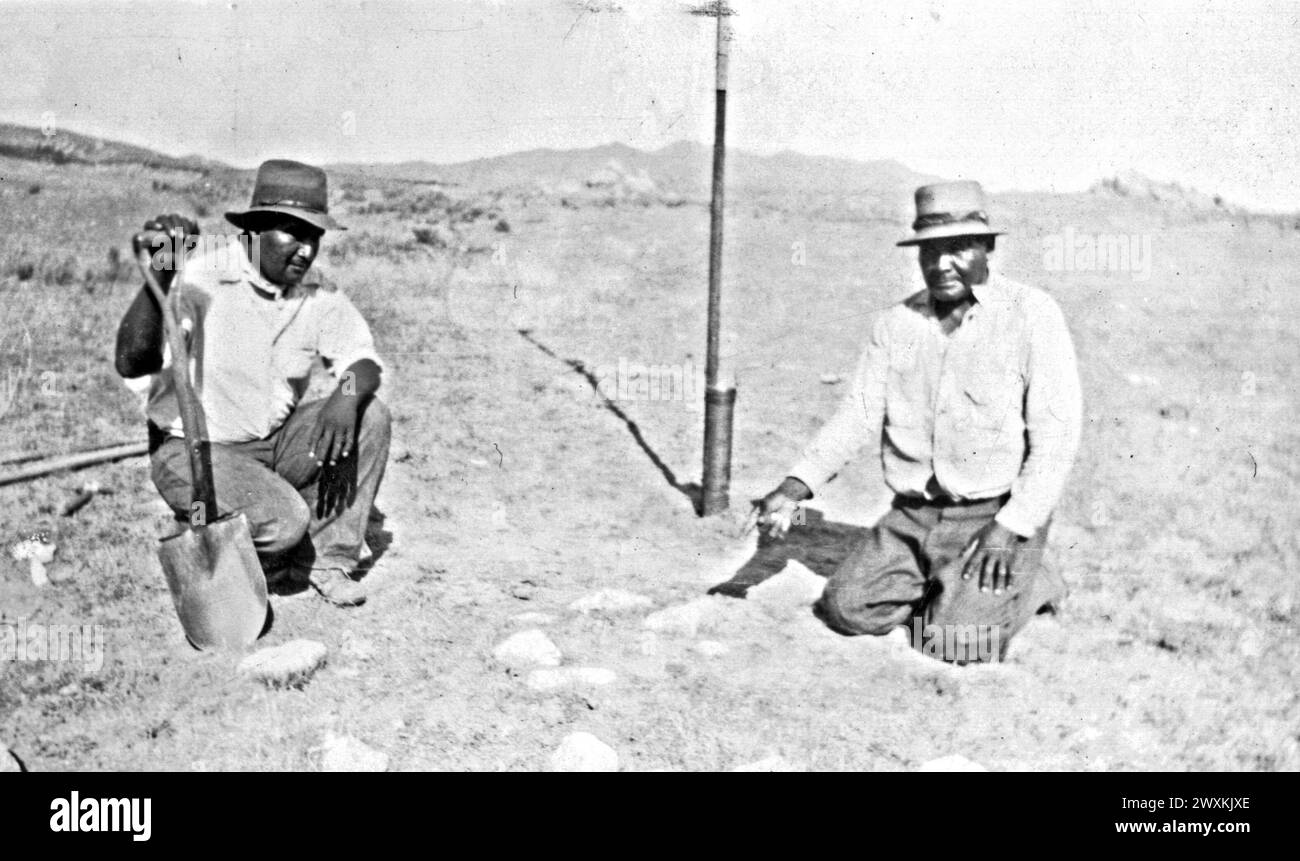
[135,243,217,524]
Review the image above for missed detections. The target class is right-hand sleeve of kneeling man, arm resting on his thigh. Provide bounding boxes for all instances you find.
[996,299,1083,537]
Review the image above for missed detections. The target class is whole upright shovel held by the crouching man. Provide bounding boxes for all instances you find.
[135,235,268,649]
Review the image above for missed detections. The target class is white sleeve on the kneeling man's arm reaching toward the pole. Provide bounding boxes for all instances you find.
[787,315,889,494]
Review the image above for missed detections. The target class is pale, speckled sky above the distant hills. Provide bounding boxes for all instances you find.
[0,0,1300,209]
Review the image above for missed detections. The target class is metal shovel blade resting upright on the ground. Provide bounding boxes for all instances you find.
[159,514,267,649]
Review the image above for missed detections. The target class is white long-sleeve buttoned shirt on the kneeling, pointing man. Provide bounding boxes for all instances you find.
[789,273,1083,537]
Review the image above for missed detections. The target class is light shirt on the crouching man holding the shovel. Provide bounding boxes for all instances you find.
[146,242,382,442]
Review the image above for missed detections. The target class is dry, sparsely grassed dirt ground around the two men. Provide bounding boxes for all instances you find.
[0,145,1300,771]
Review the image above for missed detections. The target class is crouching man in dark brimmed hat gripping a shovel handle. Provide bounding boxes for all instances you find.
[117,159,390,606]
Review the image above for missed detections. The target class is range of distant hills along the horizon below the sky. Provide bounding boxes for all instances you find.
[0,122,1292,221]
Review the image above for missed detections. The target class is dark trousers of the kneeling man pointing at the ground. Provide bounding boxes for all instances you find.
[816,497,1067,663]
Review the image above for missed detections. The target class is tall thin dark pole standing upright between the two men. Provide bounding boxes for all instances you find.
[701,0,736,516]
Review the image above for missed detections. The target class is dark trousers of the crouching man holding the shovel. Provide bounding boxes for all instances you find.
[150,398,391,571]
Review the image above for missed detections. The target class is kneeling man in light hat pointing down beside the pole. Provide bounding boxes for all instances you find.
[754,182,1082,663]
